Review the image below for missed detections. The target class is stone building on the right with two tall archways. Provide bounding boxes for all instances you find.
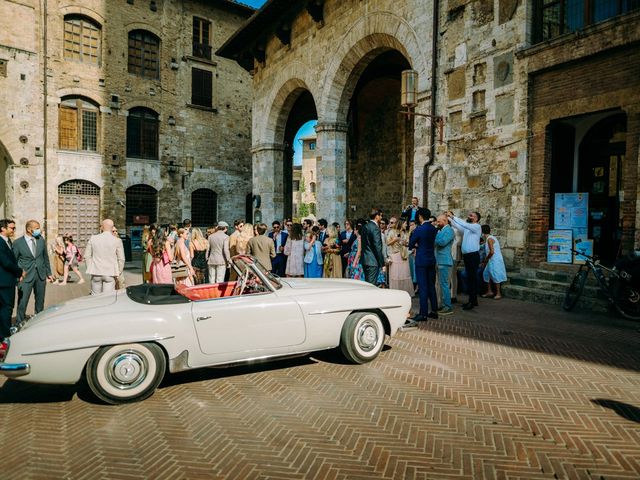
[220,0,640,266]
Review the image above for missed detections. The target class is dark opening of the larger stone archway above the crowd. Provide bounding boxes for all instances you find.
[347,50,414,218]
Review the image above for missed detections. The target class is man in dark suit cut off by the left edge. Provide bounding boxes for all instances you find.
[0,218,23,341]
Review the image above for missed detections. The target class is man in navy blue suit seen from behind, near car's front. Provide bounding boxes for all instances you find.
[409,208,438,322]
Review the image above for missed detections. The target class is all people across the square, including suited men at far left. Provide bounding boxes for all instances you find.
[0,197,507,340]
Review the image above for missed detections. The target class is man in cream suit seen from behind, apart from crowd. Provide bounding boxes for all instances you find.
[84,218,124,295]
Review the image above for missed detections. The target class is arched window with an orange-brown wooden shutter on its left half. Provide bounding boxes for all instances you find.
[58,97,100,152]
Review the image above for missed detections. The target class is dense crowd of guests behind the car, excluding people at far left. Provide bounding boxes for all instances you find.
[143,197,507,322]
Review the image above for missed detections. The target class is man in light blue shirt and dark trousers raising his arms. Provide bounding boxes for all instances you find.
[447,212,482,310]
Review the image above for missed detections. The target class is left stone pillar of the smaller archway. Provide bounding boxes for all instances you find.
[251,143,284,225]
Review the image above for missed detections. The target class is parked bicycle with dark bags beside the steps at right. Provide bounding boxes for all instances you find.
[562,249,640,320]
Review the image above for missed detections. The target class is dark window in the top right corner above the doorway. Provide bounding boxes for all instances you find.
[535,0,640,42]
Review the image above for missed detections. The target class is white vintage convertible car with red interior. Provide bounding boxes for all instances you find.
[0,256,411,404]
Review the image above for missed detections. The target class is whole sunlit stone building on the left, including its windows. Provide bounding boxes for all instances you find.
[0,0,253,248]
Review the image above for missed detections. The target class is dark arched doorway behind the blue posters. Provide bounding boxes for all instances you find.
[550,111,627,263]
